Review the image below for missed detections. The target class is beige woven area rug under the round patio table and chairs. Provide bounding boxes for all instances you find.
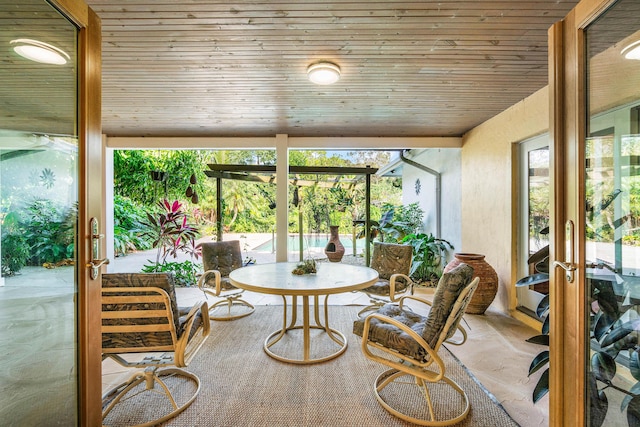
[105,306,517,427]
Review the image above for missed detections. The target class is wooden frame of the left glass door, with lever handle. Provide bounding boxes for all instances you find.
[49,0,105,426]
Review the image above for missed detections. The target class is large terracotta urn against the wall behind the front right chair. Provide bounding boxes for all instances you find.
[444,253,498,314]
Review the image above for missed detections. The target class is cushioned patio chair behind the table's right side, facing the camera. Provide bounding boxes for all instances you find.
[358,242,413,315]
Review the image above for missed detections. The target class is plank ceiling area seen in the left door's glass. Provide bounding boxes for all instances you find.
[0,0,77,136]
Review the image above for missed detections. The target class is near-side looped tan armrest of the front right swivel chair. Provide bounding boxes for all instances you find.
[362,313,445,381]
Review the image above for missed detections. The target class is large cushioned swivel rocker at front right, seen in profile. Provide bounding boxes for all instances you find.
[353,264,480,426]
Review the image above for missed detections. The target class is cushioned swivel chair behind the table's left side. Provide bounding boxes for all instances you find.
[198,240,255,320]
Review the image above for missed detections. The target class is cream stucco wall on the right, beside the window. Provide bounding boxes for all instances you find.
[456,87,549,312]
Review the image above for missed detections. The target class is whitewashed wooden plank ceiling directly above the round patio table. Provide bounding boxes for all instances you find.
[3,0,577,137]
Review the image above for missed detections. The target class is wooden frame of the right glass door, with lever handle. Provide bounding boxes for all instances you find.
[549,0,615,426]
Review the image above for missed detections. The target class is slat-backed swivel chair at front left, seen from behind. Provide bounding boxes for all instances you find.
[102,273,210,426]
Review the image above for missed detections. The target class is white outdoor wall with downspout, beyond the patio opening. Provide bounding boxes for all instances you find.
[402,148,462,258]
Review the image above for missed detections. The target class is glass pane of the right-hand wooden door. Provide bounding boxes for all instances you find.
[583,0,640,426]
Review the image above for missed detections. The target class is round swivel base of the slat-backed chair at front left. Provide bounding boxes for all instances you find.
[102,366,200,427]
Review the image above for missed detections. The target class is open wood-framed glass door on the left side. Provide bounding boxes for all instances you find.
[0,0,103,426]
